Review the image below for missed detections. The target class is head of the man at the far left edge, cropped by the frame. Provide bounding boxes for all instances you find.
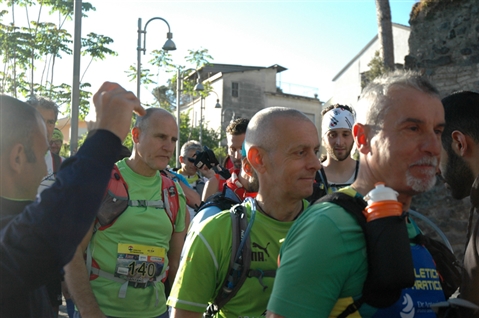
[0,95,41,161]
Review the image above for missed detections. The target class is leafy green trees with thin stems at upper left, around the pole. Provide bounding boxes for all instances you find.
[0,0,116,119]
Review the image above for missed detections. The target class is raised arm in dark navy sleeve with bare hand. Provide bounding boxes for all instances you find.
[0,82,144,299]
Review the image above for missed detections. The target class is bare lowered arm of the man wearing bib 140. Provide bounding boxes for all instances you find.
[65,247,105,318]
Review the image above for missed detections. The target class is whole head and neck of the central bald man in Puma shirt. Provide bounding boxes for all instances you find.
[245,107,321,211]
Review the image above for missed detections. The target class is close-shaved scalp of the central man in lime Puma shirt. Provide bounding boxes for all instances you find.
[245,107,314,153]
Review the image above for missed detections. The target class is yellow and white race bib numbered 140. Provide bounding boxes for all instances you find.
[115,243,166,283]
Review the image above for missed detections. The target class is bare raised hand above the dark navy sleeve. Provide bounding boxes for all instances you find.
[93,82,146,141]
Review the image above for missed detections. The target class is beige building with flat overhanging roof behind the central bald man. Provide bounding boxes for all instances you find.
[180,63,322,144]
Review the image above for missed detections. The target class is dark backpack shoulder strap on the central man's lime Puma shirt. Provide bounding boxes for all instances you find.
[203,204,256,318]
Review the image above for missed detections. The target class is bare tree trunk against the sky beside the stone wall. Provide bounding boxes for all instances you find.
[376,0,394,70]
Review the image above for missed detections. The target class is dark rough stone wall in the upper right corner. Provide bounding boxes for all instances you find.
[405,0,479,96]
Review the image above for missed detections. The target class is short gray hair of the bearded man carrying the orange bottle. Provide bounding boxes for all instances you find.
[354,70,440,127]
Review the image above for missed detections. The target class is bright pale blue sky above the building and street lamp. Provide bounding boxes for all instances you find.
[2,0,416,113]
